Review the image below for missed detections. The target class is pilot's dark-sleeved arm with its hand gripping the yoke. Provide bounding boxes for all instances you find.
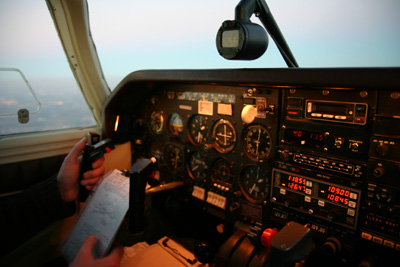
[0,138,104,258]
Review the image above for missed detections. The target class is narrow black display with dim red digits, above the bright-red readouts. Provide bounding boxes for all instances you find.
[284,128,325,148]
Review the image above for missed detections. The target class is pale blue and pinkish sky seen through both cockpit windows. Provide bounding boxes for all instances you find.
[0,0,400,135]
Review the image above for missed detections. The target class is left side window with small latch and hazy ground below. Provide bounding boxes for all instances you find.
[0,0,96,135]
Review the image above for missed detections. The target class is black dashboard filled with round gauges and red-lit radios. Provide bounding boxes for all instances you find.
[103,68,400,266]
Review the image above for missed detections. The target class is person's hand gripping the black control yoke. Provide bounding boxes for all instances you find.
[57,138,104,203]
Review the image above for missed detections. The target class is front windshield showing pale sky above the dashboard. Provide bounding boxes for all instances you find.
[89,0,400,89]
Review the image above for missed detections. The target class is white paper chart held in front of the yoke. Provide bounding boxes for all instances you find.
[61,170,129,262]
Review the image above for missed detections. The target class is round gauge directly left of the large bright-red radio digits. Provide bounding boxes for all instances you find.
[239,165,269,202]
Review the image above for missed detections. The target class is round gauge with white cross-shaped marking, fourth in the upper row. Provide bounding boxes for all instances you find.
[211,119,236,153]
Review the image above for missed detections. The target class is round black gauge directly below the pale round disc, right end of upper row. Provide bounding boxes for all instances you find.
[243,124,271,162]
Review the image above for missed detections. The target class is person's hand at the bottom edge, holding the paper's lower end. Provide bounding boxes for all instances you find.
[69,235,124,267]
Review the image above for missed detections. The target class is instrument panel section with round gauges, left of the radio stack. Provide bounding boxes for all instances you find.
[142,85,279,209]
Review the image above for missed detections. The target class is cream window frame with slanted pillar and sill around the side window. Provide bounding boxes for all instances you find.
[0,0,111,164]
